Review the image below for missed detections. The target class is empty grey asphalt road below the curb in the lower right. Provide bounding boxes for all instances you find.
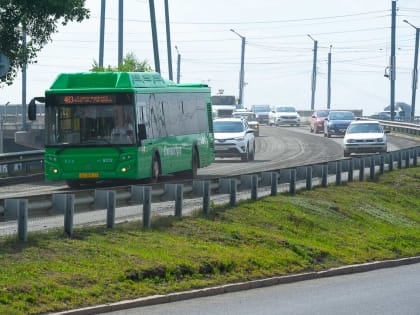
[106,264,420,315]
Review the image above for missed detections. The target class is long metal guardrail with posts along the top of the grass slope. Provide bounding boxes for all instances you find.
[0,146,420,241]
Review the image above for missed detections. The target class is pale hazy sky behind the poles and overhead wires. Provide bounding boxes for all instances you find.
[0,0,420,116]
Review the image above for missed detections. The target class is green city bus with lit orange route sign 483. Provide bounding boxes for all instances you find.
[28,72,214,187]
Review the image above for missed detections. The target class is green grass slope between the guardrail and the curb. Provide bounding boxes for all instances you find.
[0,168,420,314]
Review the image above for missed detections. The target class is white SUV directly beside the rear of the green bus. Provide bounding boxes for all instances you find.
[213,118,255,161]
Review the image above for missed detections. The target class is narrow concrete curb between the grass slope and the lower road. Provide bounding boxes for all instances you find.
[50,256,420,315]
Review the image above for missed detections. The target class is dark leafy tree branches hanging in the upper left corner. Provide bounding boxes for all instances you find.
[0,0,90,85]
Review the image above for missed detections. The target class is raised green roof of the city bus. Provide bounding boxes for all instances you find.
[46,72,207,93]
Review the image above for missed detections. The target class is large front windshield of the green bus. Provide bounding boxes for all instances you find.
[45,104,136,146]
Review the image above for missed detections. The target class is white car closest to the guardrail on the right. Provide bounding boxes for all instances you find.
[343,120,389,157]
